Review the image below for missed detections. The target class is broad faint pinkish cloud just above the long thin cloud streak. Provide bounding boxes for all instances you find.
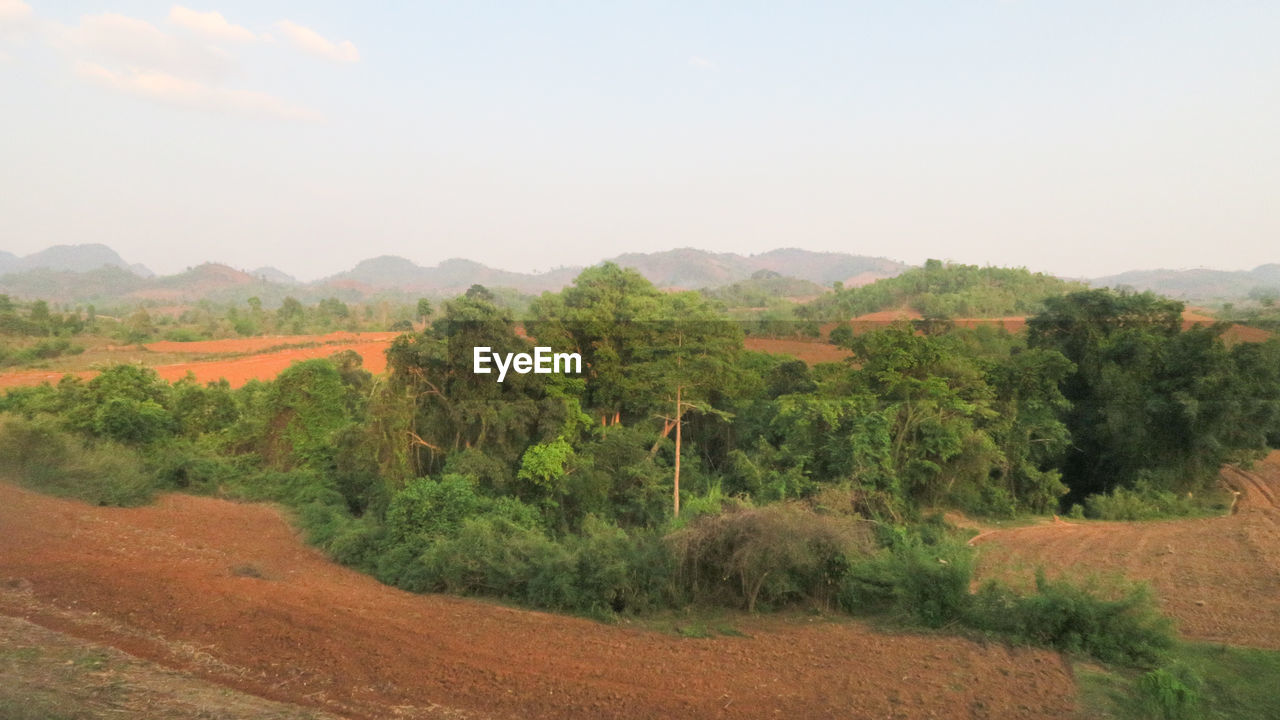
[52,11,236,82]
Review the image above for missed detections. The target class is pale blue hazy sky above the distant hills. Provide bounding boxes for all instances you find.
[0,0,1280,279]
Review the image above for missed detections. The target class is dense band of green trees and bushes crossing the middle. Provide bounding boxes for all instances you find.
[0,264,1280,659]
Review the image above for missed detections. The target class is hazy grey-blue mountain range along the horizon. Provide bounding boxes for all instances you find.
[0,243,1280,306]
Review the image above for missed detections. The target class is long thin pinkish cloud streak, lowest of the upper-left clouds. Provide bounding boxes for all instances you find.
[76,61,324,123]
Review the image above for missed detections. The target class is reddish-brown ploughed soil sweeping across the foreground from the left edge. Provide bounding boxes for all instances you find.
[0,484,1075,719]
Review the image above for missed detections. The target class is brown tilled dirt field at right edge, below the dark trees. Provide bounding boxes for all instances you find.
[975,451,1280,650]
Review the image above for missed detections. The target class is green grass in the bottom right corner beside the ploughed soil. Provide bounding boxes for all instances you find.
[1075,643,1280,720]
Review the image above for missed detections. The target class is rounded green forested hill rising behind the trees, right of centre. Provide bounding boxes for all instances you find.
[804,260,1084,320]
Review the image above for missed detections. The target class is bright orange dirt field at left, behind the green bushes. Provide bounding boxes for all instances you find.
[0,333,399,389]
